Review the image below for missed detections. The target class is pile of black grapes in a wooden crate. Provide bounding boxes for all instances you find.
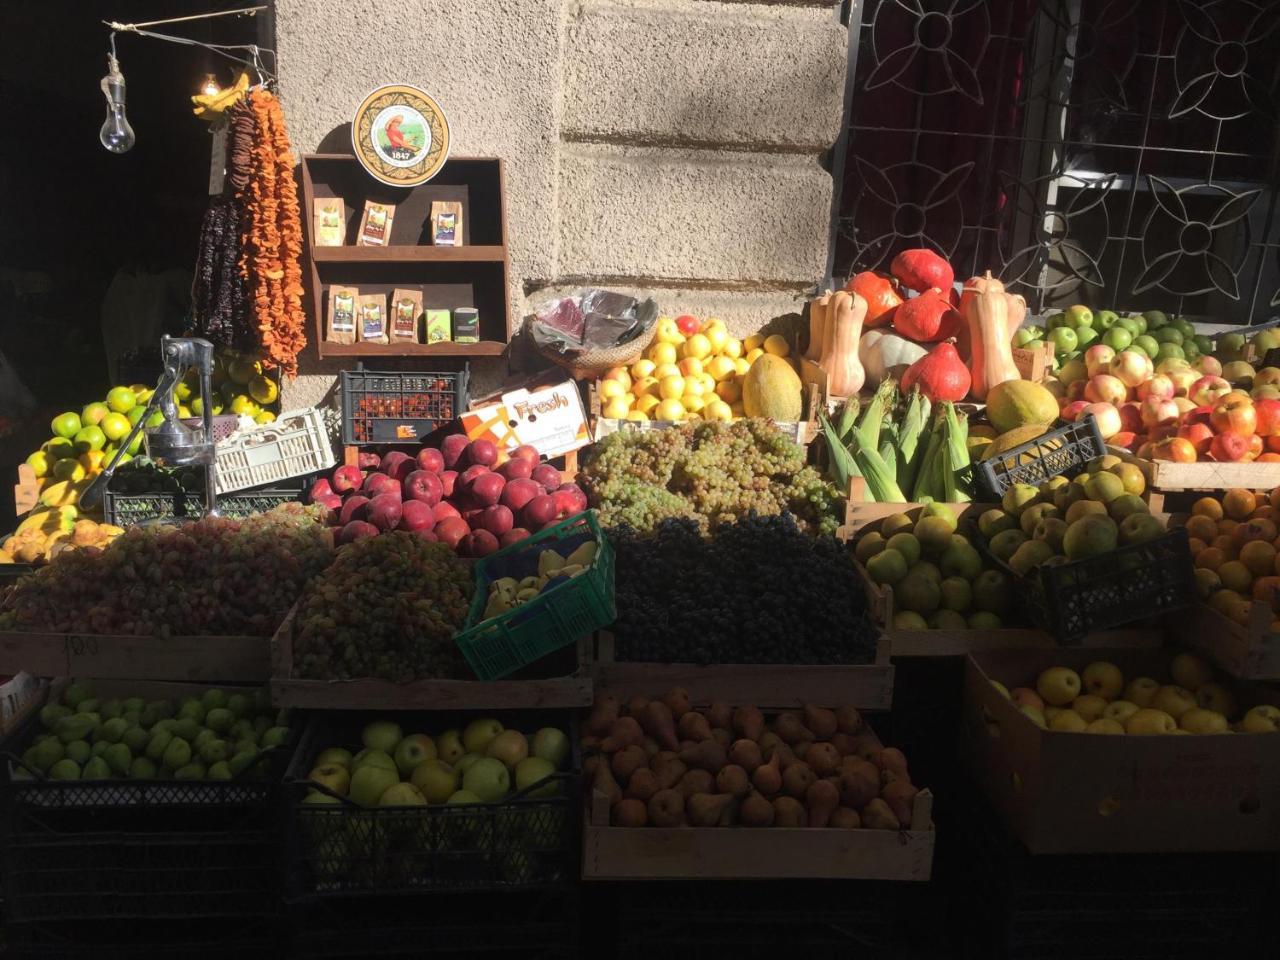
[605,513,878,664]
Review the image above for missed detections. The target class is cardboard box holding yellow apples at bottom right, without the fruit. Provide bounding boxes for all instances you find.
[960,648,1280,854]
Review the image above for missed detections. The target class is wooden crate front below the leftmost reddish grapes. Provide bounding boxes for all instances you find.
[0,631,271,684]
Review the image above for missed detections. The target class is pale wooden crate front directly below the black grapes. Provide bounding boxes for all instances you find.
[591,631,893,710]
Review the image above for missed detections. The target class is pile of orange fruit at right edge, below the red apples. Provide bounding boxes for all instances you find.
[1183,486,1280,632]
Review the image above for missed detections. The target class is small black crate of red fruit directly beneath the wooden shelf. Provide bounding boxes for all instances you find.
[340,364,470,447]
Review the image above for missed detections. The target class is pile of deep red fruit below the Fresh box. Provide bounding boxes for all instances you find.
[308,434,586,557]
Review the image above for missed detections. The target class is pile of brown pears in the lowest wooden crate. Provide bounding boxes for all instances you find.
[582,687,918,829]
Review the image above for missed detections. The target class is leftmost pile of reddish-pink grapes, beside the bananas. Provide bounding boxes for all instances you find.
[0,504,333,636]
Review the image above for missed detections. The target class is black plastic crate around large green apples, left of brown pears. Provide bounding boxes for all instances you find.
[284,712,581,902]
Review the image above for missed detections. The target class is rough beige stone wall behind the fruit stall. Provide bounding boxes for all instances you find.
[276,0,847,406]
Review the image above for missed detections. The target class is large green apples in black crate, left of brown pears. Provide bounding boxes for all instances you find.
[303,717,570,806]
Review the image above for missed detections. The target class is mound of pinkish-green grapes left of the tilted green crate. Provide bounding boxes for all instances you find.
[293,531,474,684]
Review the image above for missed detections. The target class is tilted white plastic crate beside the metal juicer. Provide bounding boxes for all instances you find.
[216,408,337,495]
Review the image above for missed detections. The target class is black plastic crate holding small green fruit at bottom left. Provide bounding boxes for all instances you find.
[0,681,289,927]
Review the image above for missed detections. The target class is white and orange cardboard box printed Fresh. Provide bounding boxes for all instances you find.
[462,380,591,457]
